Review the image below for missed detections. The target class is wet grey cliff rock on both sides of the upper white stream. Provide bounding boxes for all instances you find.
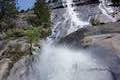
[51,0,120,41]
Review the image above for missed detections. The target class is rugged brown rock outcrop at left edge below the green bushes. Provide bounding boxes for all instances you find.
[0,38,30,80]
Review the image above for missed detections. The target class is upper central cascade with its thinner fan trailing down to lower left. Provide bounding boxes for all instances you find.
[48,0,90,44]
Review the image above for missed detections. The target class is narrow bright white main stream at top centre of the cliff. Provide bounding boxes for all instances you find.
[63,0,89,34]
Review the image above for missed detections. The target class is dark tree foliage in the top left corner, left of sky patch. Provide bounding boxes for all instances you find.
[0,0,17,32]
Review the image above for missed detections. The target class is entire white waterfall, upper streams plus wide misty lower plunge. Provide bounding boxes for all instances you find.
[8,0,120,80]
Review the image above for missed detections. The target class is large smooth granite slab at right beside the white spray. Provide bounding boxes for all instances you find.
[60,22,120,80]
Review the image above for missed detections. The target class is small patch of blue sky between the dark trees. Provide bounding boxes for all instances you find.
[17,0,35,10]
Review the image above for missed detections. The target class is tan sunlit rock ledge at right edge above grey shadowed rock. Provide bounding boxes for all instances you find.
[84,33,120,54]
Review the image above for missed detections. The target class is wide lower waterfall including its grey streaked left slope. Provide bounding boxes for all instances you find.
[8,44,112,80]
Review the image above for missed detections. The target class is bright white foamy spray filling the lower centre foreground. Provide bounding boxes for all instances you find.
[35,46,111,80]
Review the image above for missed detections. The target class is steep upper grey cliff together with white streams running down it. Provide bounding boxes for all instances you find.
[49,0,120,41]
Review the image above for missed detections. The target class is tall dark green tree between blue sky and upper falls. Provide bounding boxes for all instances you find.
[33,0,51,27]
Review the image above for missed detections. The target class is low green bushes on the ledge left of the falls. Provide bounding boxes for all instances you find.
[5,27,51,43]
